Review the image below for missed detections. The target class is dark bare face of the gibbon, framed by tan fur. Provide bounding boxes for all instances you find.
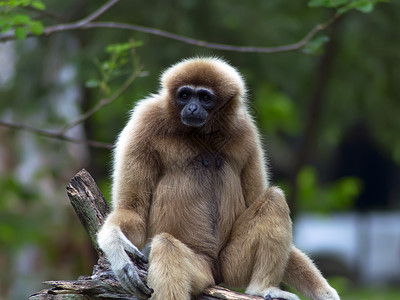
[176,86,216,127]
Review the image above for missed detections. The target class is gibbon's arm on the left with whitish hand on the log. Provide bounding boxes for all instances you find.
[98,106,159,298]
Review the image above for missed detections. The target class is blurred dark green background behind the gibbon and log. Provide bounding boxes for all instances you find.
[0,0,400,299]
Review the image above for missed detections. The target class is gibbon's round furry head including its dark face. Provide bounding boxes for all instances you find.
[161,58,246,127]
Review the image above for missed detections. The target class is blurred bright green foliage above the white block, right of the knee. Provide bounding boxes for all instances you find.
[297,167,362,213]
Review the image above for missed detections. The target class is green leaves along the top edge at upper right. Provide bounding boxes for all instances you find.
[308,0,389,14]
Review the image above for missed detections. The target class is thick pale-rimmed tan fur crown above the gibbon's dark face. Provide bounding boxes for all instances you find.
[161,57,246,102]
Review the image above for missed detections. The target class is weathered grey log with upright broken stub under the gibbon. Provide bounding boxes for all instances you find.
[29,169,262,300]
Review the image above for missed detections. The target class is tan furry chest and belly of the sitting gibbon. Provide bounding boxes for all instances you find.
[148,134,245,258]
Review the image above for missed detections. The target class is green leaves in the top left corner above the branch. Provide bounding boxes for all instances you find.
[0,0,46,40]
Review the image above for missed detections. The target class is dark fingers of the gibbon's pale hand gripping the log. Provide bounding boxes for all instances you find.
[120,264,153,299]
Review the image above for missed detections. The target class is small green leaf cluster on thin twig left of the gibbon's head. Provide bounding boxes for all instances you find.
[85,39,143,95]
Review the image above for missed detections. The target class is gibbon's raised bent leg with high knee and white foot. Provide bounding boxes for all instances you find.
[220,187,299,300]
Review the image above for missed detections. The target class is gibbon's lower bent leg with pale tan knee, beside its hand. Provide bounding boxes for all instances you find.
[147,233,214,300]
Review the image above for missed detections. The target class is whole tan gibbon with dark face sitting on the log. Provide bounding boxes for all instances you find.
[98,58,339,300]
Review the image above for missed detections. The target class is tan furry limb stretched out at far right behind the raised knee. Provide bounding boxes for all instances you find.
[283,246,340,300]
